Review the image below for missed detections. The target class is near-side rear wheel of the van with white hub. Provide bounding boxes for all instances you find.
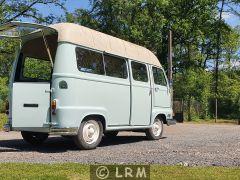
[73,118,103,150]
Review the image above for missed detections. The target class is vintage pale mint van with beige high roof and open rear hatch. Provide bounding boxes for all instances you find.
[0,22,175,149]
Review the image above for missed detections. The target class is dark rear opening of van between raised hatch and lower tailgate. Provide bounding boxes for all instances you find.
[15,35,57,82]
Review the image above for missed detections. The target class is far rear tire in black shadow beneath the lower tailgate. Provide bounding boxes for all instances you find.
[21,131,48,146]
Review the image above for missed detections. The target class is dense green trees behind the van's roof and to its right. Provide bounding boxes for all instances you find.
[63,0,240,120]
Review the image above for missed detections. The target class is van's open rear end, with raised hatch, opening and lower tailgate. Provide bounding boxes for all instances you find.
[0,22,57,132]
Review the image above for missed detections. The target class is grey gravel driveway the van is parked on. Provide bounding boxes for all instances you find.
[0,124,240,166]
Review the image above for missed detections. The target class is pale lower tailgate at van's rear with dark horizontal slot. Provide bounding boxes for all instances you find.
[12,82,50,128]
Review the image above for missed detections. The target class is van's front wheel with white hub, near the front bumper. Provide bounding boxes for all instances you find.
[146,117,163,140]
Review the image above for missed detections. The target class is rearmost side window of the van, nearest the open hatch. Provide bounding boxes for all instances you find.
[76,47,104,75]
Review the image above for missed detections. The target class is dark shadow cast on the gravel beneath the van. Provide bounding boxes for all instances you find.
[0,136,165,153]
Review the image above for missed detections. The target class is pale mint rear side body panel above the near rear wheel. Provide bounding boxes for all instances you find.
[52,43,130,128]
